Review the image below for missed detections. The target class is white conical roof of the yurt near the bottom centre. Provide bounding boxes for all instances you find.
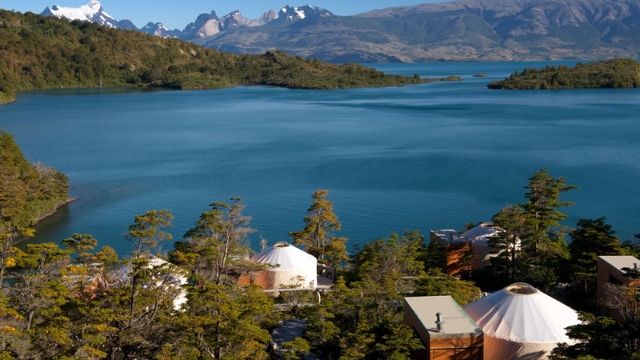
[251,241,318,270]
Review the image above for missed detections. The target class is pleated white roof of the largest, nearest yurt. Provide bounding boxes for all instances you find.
[464,283,580,343]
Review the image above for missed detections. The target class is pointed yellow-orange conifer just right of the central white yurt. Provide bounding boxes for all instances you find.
[289,190,348,267]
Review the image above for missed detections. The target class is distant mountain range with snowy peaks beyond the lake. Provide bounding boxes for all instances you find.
[43,0,640,63]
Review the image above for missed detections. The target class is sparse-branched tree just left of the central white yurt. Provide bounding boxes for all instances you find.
[179,198,256,284]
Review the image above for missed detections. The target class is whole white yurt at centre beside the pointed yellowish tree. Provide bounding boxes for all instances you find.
[251,241,318,290]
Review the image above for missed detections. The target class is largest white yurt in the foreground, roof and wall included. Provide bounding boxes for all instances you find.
[464,283,580,360]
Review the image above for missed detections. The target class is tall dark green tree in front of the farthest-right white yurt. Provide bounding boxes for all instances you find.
[475,169,577,291]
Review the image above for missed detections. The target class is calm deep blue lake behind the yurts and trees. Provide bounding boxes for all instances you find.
[0,62,640,255]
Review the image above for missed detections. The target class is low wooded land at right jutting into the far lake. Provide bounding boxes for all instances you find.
[487,59,640,90]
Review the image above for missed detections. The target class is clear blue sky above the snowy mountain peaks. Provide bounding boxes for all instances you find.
[0,0,435,30]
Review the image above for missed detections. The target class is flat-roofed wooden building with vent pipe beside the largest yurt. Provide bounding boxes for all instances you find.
[404,295,484,360]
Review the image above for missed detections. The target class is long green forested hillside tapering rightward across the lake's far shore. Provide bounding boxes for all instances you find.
[0,10,442,103]
